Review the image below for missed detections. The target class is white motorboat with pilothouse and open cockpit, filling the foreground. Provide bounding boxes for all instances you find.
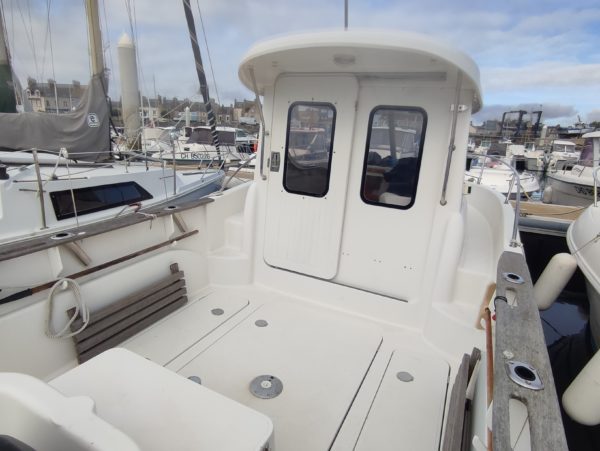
[0,25,567,451]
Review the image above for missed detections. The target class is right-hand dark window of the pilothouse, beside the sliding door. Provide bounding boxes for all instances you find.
[360,106,427,209]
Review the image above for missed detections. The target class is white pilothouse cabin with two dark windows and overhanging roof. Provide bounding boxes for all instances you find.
[239,31,481,302]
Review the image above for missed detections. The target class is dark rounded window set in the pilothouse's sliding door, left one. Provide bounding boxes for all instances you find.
[283,102,336,197]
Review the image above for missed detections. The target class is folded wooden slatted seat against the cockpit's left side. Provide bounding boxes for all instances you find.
[67,263,187,363]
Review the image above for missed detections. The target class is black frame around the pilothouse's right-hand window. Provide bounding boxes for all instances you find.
[360,105,428,210]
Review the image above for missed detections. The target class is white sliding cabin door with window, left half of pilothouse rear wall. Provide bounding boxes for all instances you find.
[264,75,358,279]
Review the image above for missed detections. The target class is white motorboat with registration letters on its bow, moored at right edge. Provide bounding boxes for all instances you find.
[544,131,600,207]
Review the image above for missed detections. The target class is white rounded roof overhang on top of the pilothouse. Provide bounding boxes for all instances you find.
[238,30,482,113]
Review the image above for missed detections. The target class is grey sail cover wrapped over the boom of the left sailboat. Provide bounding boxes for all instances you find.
[0,75,110,161]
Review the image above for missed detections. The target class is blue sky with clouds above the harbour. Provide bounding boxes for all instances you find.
[0,0,600,125]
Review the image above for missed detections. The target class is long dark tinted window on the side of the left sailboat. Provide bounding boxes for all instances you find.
[50,182,152,220]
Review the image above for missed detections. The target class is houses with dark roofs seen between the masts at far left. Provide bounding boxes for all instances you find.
[25,77,87,113]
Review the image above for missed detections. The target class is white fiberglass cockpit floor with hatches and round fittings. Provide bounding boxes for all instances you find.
[111,286,449,450]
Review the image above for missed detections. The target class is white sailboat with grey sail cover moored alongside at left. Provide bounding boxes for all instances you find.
[0,0,224,247]
